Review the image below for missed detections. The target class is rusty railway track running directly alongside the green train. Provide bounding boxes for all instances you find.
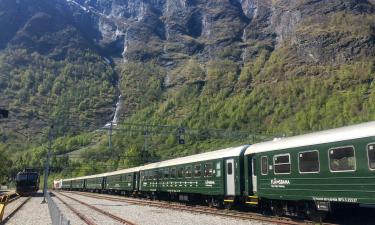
[59,192,335,225]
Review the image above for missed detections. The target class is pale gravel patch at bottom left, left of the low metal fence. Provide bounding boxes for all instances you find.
[6,193,52,225]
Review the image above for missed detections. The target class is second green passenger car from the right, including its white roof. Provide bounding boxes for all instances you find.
[139,146,247,204]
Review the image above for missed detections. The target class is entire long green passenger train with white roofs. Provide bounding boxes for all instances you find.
[62,122,375,219]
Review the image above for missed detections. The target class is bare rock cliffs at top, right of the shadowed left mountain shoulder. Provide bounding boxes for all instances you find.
[58,0,374,65]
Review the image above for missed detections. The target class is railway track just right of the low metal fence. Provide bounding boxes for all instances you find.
[52,192,137,225]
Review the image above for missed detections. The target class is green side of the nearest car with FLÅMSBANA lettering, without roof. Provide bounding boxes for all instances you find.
[248,137,375,209]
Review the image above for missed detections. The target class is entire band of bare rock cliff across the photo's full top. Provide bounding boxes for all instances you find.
[0,0,375,66]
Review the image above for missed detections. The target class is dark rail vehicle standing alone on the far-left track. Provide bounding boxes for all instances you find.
[16,169,39,196]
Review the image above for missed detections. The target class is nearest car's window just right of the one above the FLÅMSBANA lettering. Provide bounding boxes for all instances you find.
[298,150,320,173]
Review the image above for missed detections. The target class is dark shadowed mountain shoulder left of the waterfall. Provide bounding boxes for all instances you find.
[0,0,117,139]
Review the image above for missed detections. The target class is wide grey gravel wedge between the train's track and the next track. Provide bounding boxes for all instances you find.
[60,192,271,225]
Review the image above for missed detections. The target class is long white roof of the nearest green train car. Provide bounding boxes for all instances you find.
[245,121,375,155]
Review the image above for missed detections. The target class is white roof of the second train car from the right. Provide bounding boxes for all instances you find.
[141,145,248,170]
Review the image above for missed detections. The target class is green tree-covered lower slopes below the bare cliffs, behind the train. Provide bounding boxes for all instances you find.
[0,7,375,185]
